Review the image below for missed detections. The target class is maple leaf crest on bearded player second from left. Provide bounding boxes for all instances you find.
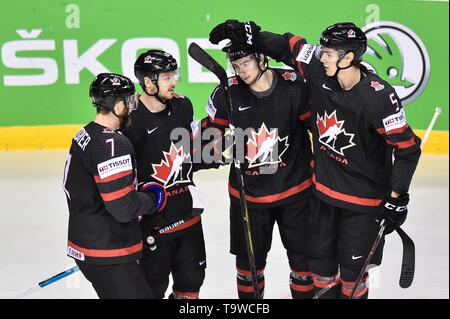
[152,142,192,187]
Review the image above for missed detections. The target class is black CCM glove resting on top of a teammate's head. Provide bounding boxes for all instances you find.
[209,20,261,48]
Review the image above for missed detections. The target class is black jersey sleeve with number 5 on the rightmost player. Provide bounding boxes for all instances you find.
[371,86,421,194]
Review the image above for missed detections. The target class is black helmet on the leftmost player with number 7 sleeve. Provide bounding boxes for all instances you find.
[89,73,136,112]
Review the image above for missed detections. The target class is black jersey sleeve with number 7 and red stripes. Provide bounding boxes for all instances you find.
[90,133,155,223]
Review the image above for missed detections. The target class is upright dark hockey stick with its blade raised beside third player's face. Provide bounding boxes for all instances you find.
[188,42,261,299]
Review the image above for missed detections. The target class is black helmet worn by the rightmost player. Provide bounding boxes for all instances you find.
[320,22,367,64]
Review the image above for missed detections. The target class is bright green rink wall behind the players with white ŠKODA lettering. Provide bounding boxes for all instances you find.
[0,0,449,130]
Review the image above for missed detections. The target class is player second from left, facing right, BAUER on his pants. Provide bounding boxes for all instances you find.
[124,50,210,299]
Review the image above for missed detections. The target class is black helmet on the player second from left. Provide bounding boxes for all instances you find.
[134,50,178,86]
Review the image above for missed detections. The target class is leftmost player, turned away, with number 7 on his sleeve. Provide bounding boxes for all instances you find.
[63,73,166,299]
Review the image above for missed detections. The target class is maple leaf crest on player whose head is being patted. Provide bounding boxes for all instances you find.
[245,123,289,168]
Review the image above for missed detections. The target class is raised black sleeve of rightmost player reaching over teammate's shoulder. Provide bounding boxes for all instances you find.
[261,32,317,80]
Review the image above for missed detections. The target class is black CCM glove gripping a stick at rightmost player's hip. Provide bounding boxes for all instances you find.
[382,193,409,235]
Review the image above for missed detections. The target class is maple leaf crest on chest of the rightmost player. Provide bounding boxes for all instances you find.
[316,110,355,155]
